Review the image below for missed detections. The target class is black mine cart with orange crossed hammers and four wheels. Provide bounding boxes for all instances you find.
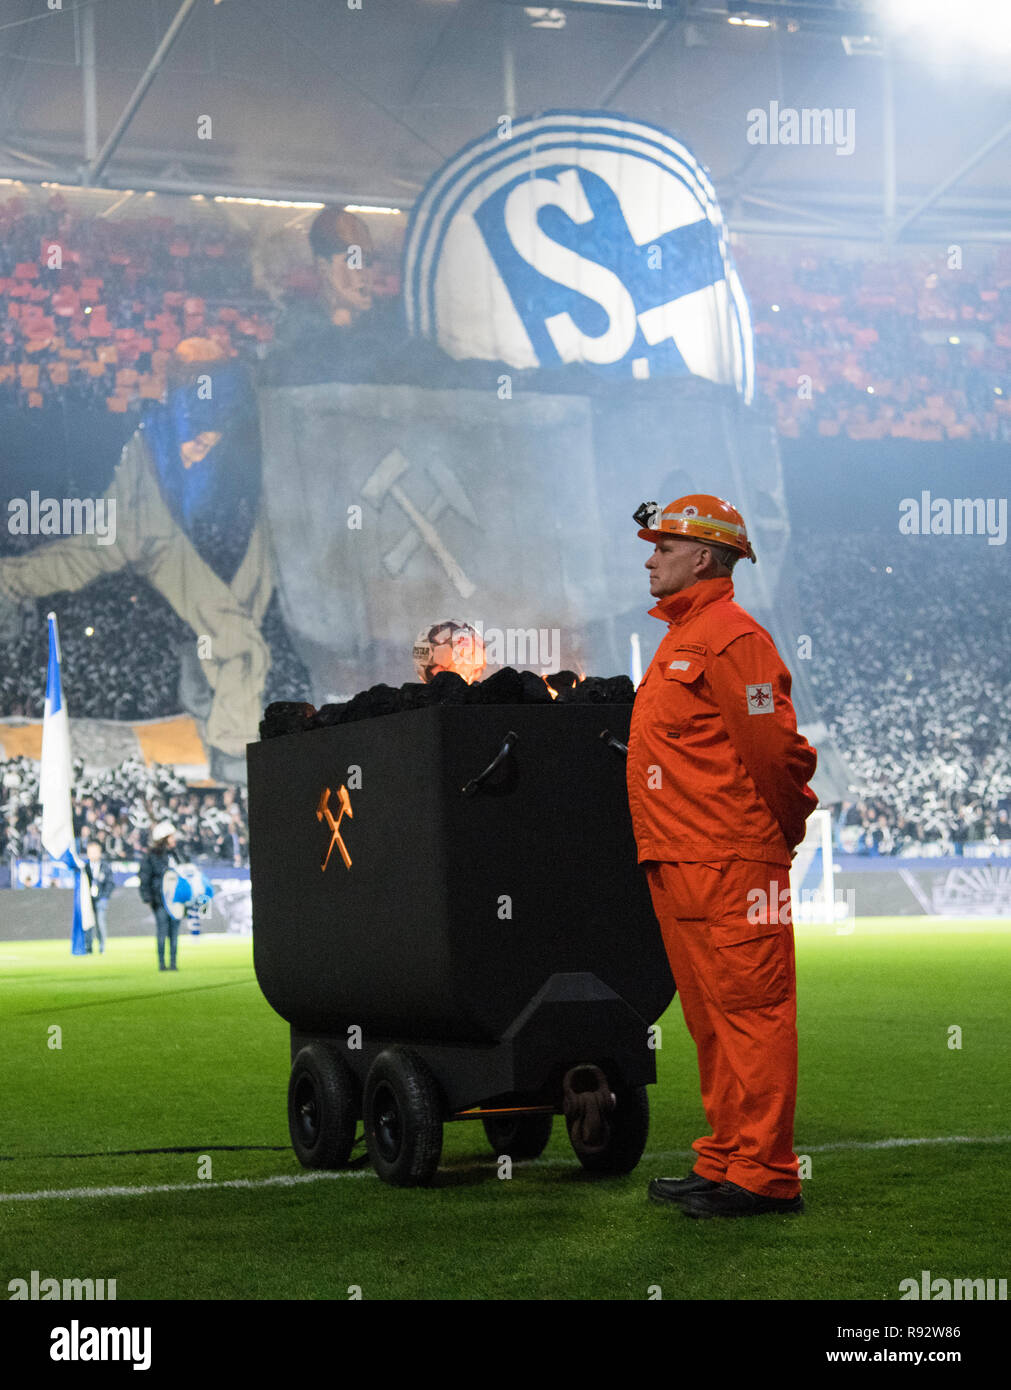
[249,703,674,1186]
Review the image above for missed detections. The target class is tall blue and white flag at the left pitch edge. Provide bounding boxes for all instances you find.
[39,613,95,955]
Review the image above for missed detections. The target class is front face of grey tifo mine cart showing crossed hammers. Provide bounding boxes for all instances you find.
[261,384,605,699]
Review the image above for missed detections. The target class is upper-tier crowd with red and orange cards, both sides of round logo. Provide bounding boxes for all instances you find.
[0,193,1011,442]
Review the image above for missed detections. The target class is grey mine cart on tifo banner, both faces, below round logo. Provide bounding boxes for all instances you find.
[261,382,787,702]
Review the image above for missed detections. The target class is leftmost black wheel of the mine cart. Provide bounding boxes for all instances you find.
[288,1043,357,1168]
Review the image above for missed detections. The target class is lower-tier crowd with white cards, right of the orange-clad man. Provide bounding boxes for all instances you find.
[794,531,1011,855]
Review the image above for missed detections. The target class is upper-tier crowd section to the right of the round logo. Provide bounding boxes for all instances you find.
[736,247,1011,443]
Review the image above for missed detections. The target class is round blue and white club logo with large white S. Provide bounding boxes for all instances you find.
[403,111,754,400]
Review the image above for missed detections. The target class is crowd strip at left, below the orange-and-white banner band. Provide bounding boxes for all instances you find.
[0,758,249,866]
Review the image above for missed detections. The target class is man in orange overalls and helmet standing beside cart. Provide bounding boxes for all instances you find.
[627,495,818,1218]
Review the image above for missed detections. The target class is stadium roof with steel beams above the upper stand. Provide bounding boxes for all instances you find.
[0,0,1011,245]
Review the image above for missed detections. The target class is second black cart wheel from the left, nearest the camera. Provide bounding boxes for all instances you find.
[363,1047,444,1187]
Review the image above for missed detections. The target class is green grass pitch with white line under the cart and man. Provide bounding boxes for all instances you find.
[0,919,1011,1300]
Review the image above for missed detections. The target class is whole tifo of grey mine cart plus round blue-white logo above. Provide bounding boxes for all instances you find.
[260,111,788,702]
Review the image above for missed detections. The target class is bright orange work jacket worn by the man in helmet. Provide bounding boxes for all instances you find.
[627,578,818,867]
